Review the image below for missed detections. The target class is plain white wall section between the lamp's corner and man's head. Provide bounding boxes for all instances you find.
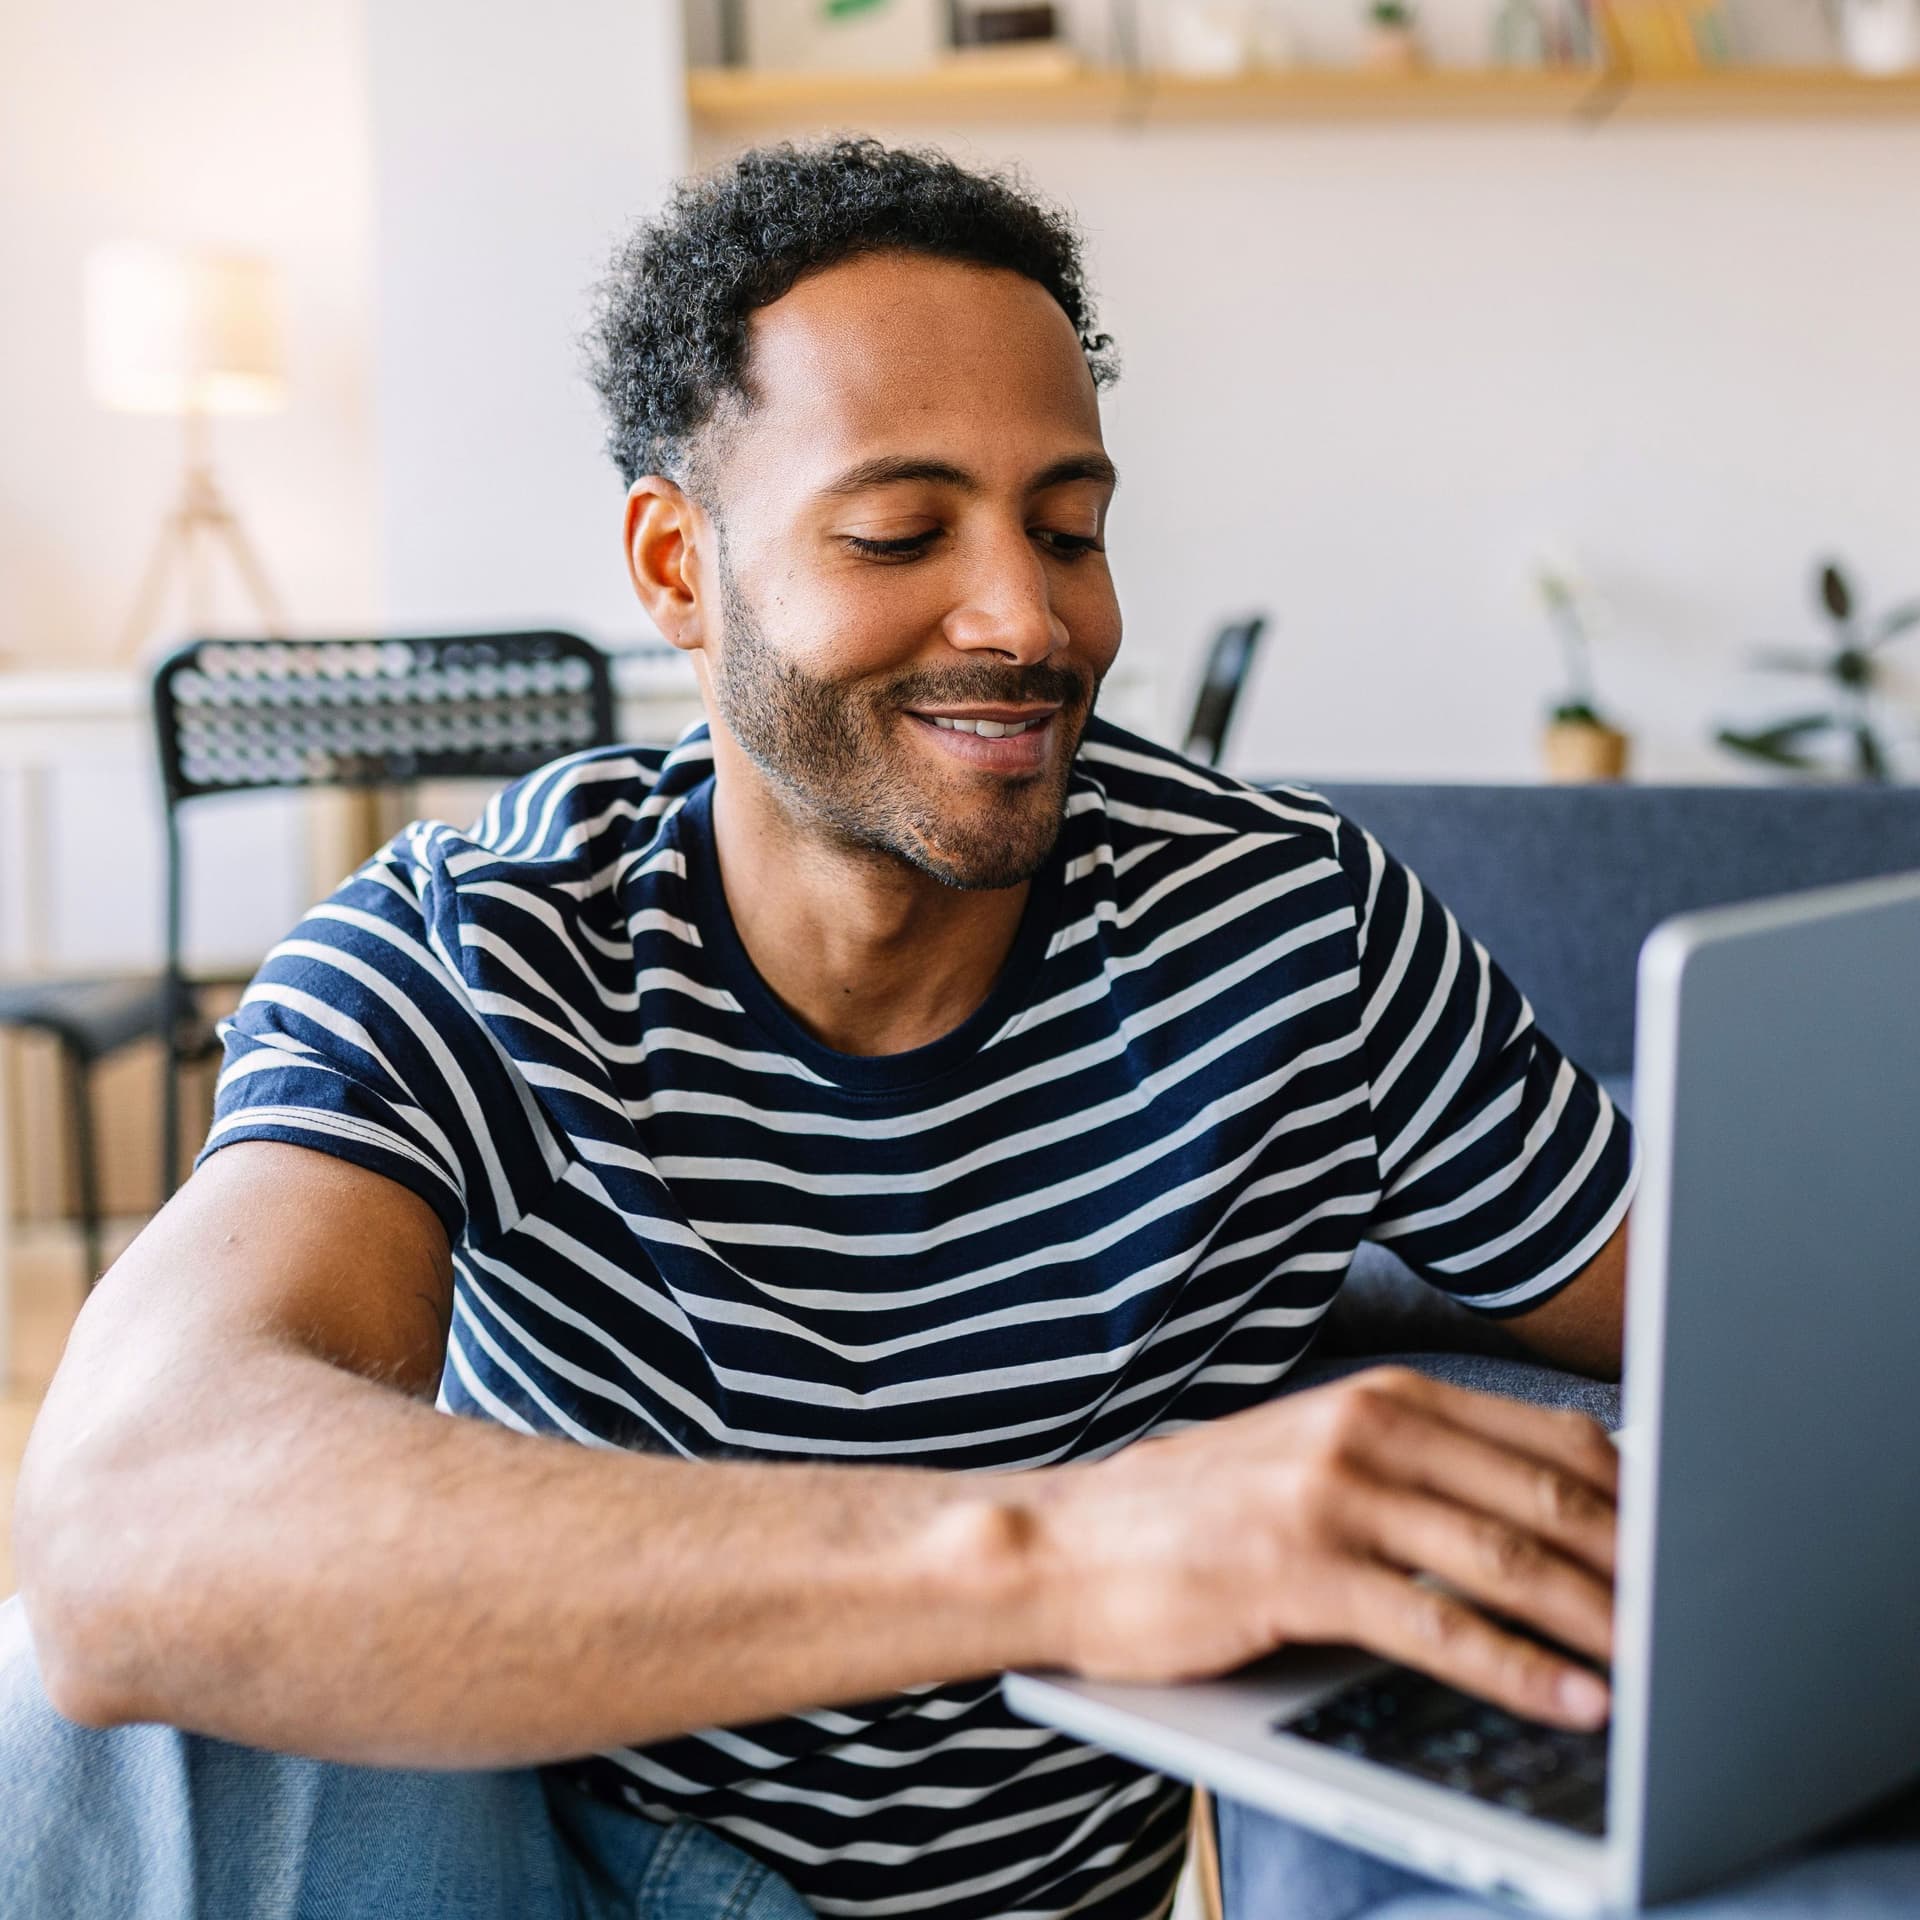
[369,0,685,643]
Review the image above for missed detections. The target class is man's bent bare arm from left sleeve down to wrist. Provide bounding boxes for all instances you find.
[17,1142,1039,1764]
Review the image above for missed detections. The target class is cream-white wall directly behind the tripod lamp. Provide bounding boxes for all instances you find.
[0,0,374,666]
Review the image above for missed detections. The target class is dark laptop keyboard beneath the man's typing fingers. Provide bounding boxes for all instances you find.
[1273,1667,1607,1834]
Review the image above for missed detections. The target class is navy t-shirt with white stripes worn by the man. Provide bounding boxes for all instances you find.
[207,720,1632,1920]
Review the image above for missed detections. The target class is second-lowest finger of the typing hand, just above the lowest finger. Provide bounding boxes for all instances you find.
[1363,1490,1613,1661]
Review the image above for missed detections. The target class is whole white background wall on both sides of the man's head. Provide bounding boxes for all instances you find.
[0,0,1920,791]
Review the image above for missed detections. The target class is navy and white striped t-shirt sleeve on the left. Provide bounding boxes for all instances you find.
[200,829,545,1242]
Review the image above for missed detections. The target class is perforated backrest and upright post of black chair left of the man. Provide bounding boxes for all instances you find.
[154,634,614,1192]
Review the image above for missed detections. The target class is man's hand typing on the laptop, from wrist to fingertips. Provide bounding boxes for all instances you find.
[1039,1367,1619,1726]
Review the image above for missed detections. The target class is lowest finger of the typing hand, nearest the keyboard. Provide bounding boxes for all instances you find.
[1350,1567,1611,1728]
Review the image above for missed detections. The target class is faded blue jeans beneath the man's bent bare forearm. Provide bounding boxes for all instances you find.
[0,1599,812,1920]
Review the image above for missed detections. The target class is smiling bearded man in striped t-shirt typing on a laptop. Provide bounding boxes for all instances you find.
[0,142,1632,1916]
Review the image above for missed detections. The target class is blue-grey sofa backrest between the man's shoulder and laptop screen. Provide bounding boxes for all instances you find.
[1317,783,1920,1077]
